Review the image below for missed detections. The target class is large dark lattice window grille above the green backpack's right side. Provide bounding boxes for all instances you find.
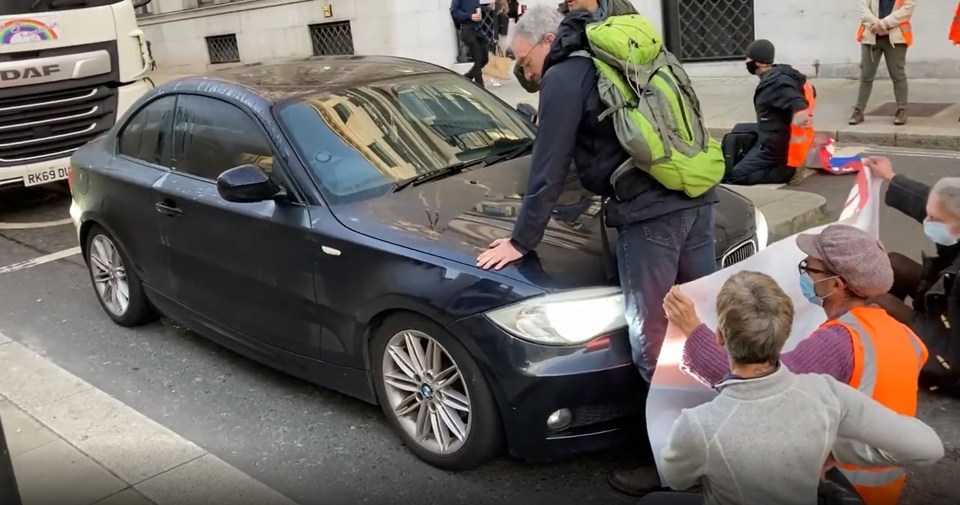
[663,0,754,61]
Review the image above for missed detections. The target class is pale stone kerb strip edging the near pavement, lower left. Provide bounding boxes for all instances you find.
[0,334,296,505]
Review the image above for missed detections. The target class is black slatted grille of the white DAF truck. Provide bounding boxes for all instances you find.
[0,85,117,166]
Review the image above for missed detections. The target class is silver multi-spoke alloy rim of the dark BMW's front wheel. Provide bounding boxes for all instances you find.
[383,330,473,454]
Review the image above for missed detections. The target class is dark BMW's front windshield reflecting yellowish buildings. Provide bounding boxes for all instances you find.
[276,74,535,202]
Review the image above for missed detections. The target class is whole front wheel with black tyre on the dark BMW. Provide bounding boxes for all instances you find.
[370,313,503,471]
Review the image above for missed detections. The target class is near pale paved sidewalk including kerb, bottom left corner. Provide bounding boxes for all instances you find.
[0,334,296,505]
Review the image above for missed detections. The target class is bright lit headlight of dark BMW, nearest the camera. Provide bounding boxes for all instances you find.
[486,287,627,346]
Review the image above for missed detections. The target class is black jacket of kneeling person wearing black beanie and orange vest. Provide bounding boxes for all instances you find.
[753,65,807,161]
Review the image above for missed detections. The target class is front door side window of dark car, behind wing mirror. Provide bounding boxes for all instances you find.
[172,95,273,180]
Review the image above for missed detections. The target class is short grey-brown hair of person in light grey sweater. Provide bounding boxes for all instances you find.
[717,270,794,365]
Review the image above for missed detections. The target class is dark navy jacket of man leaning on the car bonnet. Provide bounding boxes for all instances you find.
[512,11,717,252]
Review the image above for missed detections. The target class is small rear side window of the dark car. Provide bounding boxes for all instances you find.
[117,96,176,165]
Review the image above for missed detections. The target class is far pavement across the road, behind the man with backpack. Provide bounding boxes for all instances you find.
[484,71,960,150]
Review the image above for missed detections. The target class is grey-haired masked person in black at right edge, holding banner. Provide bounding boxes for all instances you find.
[864,157,960,394]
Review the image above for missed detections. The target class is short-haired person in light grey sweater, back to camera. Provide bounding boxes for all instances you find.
[640,271,944,505]
